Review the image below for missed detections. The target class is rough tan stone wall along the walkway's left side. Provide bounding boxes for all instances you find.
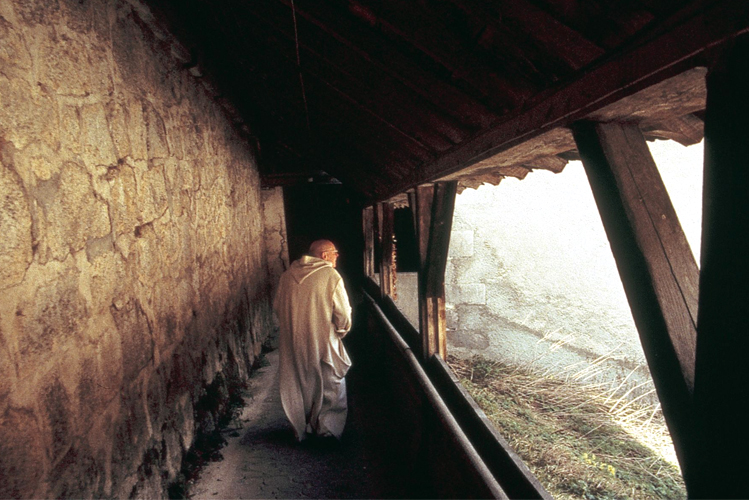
[0,0,271,498]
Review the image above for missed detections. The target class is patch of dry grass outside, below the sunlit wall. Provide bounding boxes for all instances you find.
[448,357,686,499]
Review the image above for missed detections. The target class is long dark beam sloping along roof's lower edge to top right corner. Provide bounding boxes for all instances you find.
[384,0,749,203]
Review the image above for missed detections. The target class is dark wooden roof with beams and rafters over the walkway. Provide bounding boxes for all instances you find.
[148,0,749,203]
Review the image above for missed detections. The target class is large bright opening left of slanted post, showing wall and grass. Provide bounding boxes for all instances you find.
[446,154,691,498]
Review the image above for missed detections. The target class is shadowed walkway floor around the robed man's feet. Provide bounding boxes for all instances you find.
[186,322,434,499]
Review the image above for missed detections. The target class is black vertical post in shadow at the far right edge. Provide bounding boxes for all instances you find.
[687,35,749,498]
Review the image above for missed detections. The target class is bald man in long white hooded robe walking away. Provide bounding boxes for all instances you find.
[273,240,351,441]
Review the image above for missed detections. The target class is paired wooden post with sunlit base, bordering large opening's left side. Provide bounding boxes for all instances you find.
[409,182,457,359]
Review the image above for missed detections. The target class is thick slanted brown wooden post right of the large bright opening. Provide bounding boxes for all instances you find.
[573,122,699,477]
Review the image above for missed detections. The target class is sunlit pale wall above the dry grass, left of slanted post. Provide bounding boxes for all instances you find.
[446,172,657,401]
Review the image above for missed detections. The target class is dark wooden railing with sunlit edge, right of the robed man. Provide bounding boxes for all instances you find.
[364,282,551,499]
